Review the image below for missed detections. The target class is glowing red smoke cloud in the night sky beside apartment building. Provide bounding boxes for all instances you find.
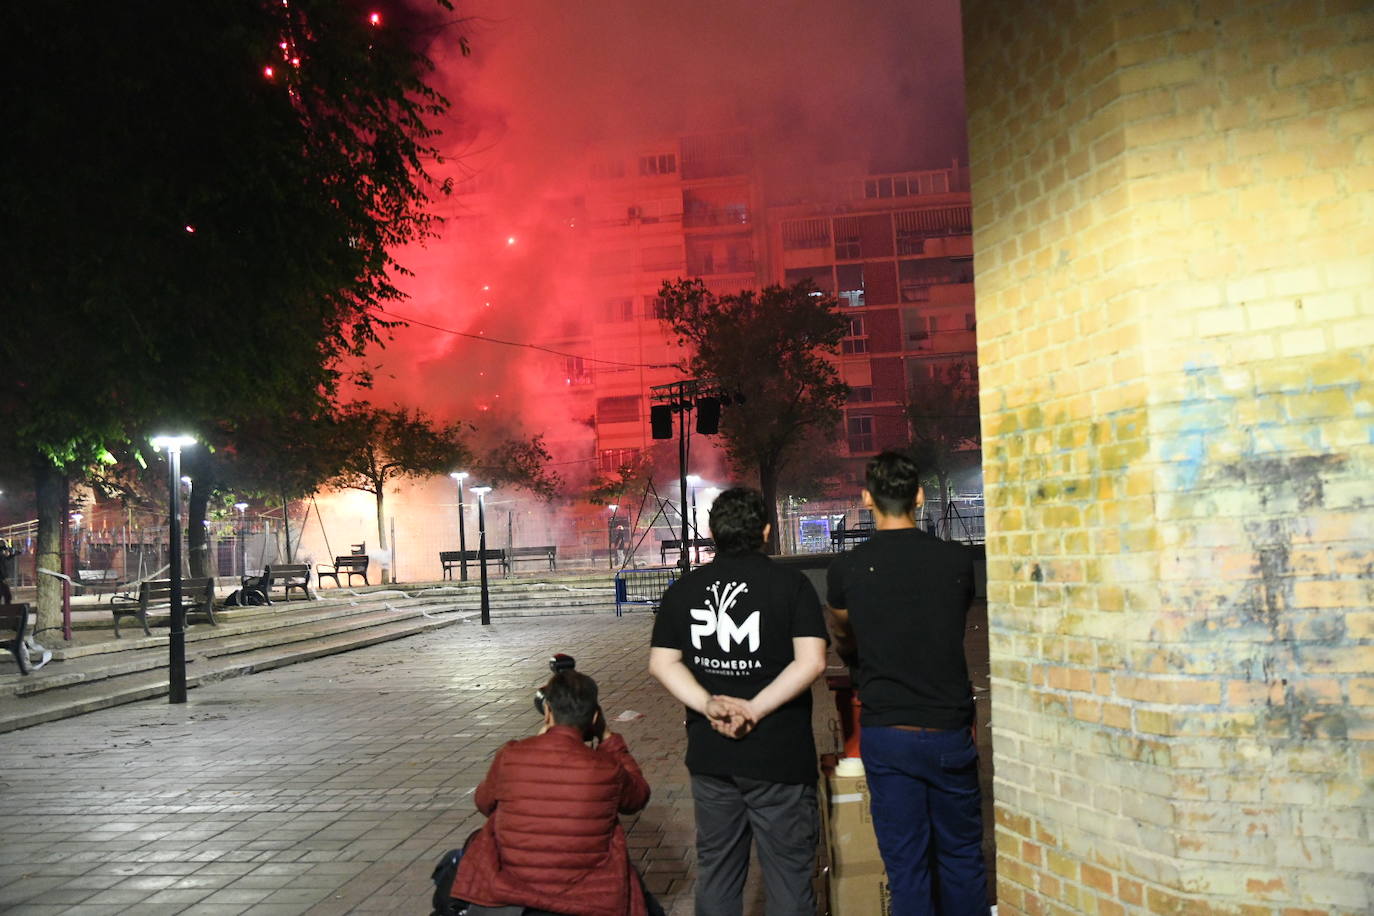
[343,0,966,497]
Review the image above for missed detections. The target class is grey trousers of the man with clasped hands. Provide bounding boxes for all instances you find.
[691,775,820,916]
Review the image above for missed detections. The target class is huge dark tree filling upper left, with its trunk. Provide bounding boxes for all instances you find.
[0,0,456,629]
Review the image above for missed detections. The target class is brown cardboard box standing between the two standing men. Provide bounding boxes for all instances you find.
[820,754,892,916]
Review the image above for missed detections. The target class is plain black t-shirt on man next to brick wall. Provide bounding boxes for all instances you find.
[826,527,973,728]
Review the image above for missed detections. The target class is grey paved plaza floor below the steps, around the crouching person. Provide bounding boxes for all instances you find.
[0,612,785,916]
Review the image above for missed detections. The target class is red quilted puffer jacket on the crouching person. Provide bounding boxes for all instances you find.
[453,725,649,916]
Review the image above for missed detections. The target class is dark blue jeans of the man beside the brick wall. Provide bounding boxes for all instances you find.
[859,726,988,916]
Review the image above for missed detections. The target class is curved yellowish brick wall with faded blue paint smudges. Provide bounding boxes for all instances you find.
[963,0,1374,916]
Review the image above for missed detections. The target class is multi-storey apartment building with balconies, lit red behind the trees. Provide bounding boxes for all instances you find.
[450,132,976,494]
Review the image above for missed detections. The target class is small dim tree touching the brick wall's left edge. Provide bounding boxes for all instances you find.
[907,360,982,503]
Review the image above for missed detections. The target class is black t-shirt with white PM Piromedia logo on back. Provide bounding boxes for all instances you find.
[653,553,826,784]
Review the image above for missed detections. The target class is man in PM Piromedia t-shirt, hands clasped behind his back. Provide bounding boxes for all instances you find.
[649,488,826,916]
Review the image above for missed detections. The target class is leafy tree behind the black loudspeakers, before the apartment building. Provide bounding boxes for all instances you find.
[660,280,849,552]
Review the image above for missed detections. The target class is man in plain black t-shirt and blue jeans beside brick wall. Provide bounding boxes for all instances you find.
[826,452,988,916]
